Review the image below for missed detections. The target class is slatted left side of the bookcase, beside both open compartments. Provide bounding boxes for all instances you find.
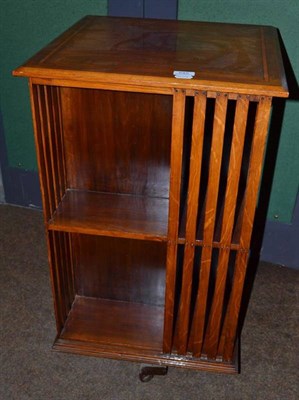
[30,82,75,332]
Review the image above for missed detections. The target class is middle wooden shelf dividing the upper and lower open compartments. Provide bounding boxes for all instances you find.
[48,190,169,241]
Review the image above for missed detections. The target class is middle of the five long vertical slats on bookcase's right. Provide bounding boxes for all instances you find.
[190,94,228,357]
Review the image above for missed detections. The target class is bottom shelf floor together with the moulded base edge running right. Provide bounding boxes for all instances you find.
[53,296,238,374]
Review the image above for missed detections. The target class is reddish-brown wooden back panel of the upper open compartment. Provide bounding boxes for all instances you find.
[61,88,172,198]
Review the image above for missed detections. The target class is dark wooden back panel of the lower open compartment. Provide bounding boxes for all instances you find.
[72,234,167,307]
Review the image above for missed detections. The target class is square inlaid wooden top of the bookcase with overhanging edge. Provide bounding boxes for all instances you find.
[13,16,288,97]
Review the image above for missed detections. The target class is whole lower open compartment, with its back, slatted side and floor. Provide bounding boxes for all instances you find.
[49,230,166,354]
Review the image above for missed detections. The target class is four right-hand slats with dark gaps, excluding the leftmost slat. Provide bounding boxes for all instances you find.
[172,93,271,361]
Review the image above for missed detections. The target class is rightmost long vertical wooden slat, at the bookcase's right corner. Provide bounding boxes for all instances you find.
[218,97,271,360]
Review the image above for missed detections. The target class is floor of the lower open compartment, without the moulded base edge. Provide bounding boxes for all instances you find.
[60,296,164,353]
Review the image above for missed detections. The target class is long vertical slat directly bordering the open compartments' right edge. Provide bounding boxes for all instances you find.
[163,90,186,353]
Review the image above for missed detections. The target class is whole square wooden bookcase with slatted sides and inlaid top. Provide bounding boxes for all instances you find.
[14,16,288,373]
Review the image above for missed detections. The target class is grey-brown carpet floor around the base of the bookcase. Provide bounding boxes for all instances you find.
[0,205,299,400]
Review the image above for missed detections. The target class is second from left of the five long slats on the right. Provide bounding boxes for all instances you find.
[175,93,206,354]
